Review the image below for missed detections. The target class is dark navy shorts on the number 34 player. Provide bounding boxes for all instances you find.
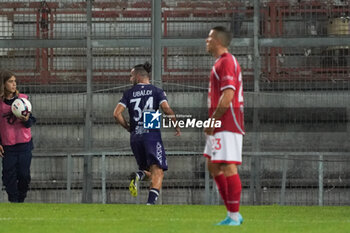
[130,135,168,171]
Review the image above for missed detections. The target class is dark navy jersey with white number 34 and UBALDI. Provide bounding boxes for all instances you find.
[119,83,167,134]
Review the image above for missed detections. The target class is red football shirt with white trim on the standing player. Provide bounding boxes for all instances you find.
[208,53,245,134]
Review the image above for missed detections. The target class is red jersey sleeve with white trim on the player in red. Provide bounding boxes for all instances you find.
[217,59,238,91]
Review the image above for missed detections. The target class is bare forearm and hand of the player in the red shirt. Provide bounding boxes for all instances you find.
[204,88,235,135]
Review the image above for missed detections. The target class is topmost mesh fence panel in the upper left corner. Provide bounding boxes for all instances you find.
[0,0,86,39]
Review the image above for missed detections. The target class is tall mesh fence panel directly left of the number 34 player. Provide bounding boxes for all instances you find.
[93,47,151,151]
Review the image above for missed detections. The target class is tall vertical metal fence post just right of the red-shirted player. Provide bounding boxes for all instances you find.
[250,0,261,204]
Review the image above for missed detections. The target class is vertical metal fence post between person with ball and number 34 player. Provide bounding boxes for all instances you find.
[82,0,92,203]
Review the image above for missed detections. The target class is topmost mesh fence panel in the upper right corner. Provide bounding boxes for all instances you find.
[261,0,350,37]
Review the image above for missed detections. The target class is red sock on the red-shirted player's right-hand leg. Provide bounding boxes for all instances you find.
[226,174,242,212]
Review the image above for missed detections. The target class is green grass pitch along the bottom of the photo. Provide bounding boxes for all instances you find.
[0,203,350,233]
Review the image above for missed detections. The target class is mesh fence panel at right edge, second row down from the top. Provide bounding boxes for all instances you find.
[260,46,350,91]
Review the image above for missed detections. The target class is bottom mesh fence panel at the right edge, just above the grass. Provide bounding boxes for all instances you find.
[260,154,349,205]
